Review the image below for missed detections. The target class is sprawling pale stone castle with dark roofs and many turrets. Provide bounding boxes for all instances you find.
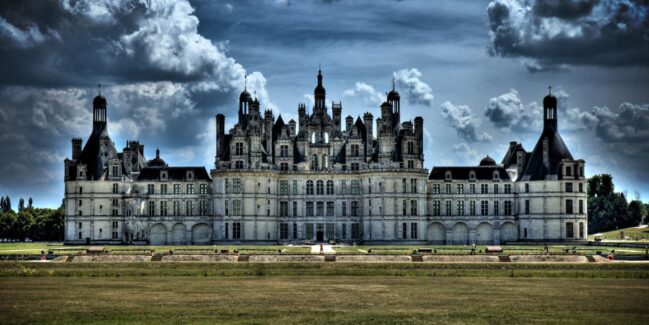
[64,71,587,245]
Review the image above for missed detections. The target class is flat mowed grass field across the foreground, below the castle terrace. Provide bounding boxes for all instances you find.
[0,262,649,324]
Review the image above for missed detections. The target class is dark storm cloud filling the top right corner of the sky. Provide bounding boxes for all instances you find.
[487,0,649,72]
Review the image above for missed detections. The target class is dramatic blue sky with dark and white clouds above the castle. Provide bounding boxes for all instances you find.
[0,0,649,207]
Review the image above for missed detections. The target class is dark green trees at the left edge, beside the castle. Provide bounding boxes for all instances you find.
[0,196,65,241]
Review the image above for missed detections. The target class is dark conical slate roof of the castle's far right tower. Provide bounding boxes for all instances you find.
[520,128,573,181]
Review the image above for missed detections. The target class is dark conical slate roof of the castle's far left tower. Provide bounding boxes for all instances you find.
[77,124,117,180]
